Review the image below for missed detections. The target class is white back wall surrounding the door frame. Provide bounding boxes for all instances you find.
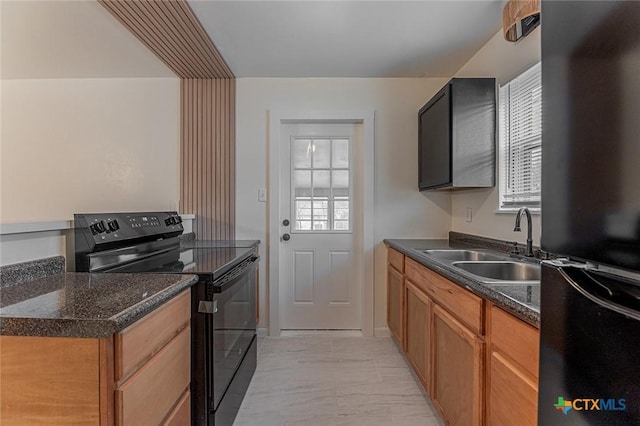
[236,79,450,328]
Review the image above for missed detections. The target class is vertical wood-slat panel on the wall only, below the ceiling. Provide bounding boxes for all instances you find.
[180,79,235,240]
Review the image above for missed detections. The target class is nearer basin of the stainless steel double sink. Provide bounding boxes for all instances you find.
[452,261,540,282]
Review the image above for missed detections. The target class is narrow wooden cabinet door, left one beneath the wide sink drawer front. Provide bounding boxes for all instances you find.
[405,281,432,392]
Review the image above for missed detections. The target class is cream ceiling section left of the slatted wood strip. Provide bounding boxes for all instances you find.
[0,0,175,79]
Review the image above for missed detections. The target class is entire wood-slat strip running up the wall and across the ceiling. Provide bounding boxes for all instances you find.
[98,0,235,239]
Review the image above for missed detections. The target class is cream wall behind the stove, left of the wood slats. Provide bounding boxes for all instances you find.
[0,78,180,222]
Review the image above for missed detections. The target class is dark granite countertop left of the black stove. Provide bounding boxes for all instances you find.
[0,273,198,338]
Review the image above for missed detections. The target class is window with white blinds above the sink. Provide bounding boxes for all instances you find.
[499,63,542,210]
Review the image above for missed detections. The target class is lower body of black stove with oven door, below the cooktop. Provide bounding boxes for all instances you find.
[191,256,259,425]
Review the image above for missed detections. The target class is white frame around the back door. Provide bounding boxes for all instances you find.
[267,110,375,336]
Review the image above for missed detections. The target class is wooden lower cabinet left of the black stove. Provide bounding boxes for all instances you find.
[0,291,191,426]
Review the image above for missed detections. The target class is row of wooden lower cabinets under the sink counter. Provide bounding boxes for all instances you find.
[387,249,540,426]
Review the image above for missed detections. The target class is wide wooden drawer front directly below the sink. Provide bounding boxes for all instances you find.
[405,259,483,335]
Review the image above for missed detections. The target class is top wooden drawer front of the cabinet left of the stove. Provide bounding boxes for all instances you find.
[115,290,191,382]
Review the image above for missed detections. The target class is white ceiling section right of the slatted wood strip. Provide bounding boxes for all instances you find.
[189,0,505,78]
